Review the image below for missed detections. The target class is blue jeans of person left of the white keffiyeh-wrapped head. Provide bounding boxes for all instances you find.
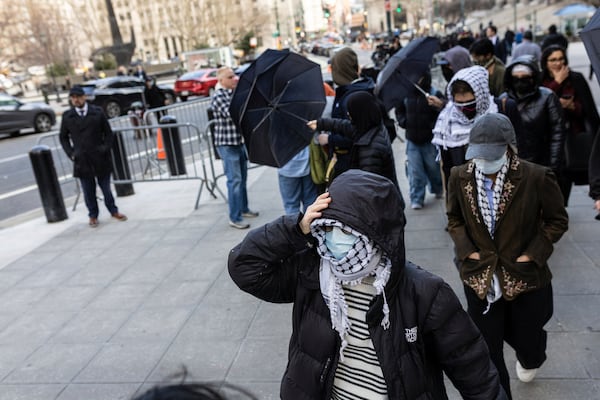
[406,140,444,205]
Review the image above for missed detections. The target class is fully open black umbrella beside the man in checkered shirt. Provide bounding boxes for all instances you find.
[229,49,325,167]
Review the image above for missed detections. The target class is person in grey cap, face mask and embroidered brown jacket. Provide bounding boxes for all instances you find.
[447,113,568,397]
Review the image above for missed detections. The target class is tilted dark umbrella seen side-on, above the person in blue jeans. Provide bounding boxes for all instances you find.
[375,36,440,111]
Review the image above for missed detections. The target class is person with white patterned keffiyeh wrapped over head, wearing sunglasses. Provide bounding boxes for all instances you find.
[431,66,522,195]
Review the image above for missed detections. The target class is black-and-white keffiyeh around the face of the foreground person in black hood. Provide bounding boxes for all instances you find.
[310,218,392,360]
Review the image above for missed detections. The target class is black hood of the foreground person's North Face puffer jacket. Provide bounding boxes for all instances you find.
[322,169,406,266]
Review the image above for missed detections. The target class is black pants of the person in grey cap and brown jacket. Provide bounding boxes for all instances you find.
[465,285,553,398]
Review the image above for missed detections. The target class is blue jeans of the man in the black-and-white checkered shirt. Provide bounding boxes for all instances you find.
[216,144,248,222]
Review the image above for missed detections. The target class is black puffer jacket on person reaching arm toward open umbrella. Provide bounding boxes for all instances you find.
[317,118,399,187]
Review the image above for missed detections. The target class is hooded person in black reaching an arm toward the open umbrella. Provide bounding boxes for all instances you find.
[308,92,398,187]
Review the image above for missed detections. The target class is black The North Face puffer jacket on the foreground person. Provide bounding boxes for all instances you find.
[229,170,504,400]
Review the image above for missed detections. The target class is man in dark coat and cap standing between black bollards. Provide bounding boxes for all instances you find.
[59,86,127,228]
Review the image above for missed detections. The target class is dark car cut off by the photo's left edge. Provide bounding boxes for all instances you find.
[0,93,56,136]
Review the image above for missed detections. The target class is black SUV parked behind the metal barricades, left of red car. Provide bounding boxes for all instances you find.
[81,76,175,118]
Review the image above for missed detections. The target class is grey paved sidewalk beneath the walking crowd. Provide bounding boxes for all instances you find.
[0,135,600,400]
